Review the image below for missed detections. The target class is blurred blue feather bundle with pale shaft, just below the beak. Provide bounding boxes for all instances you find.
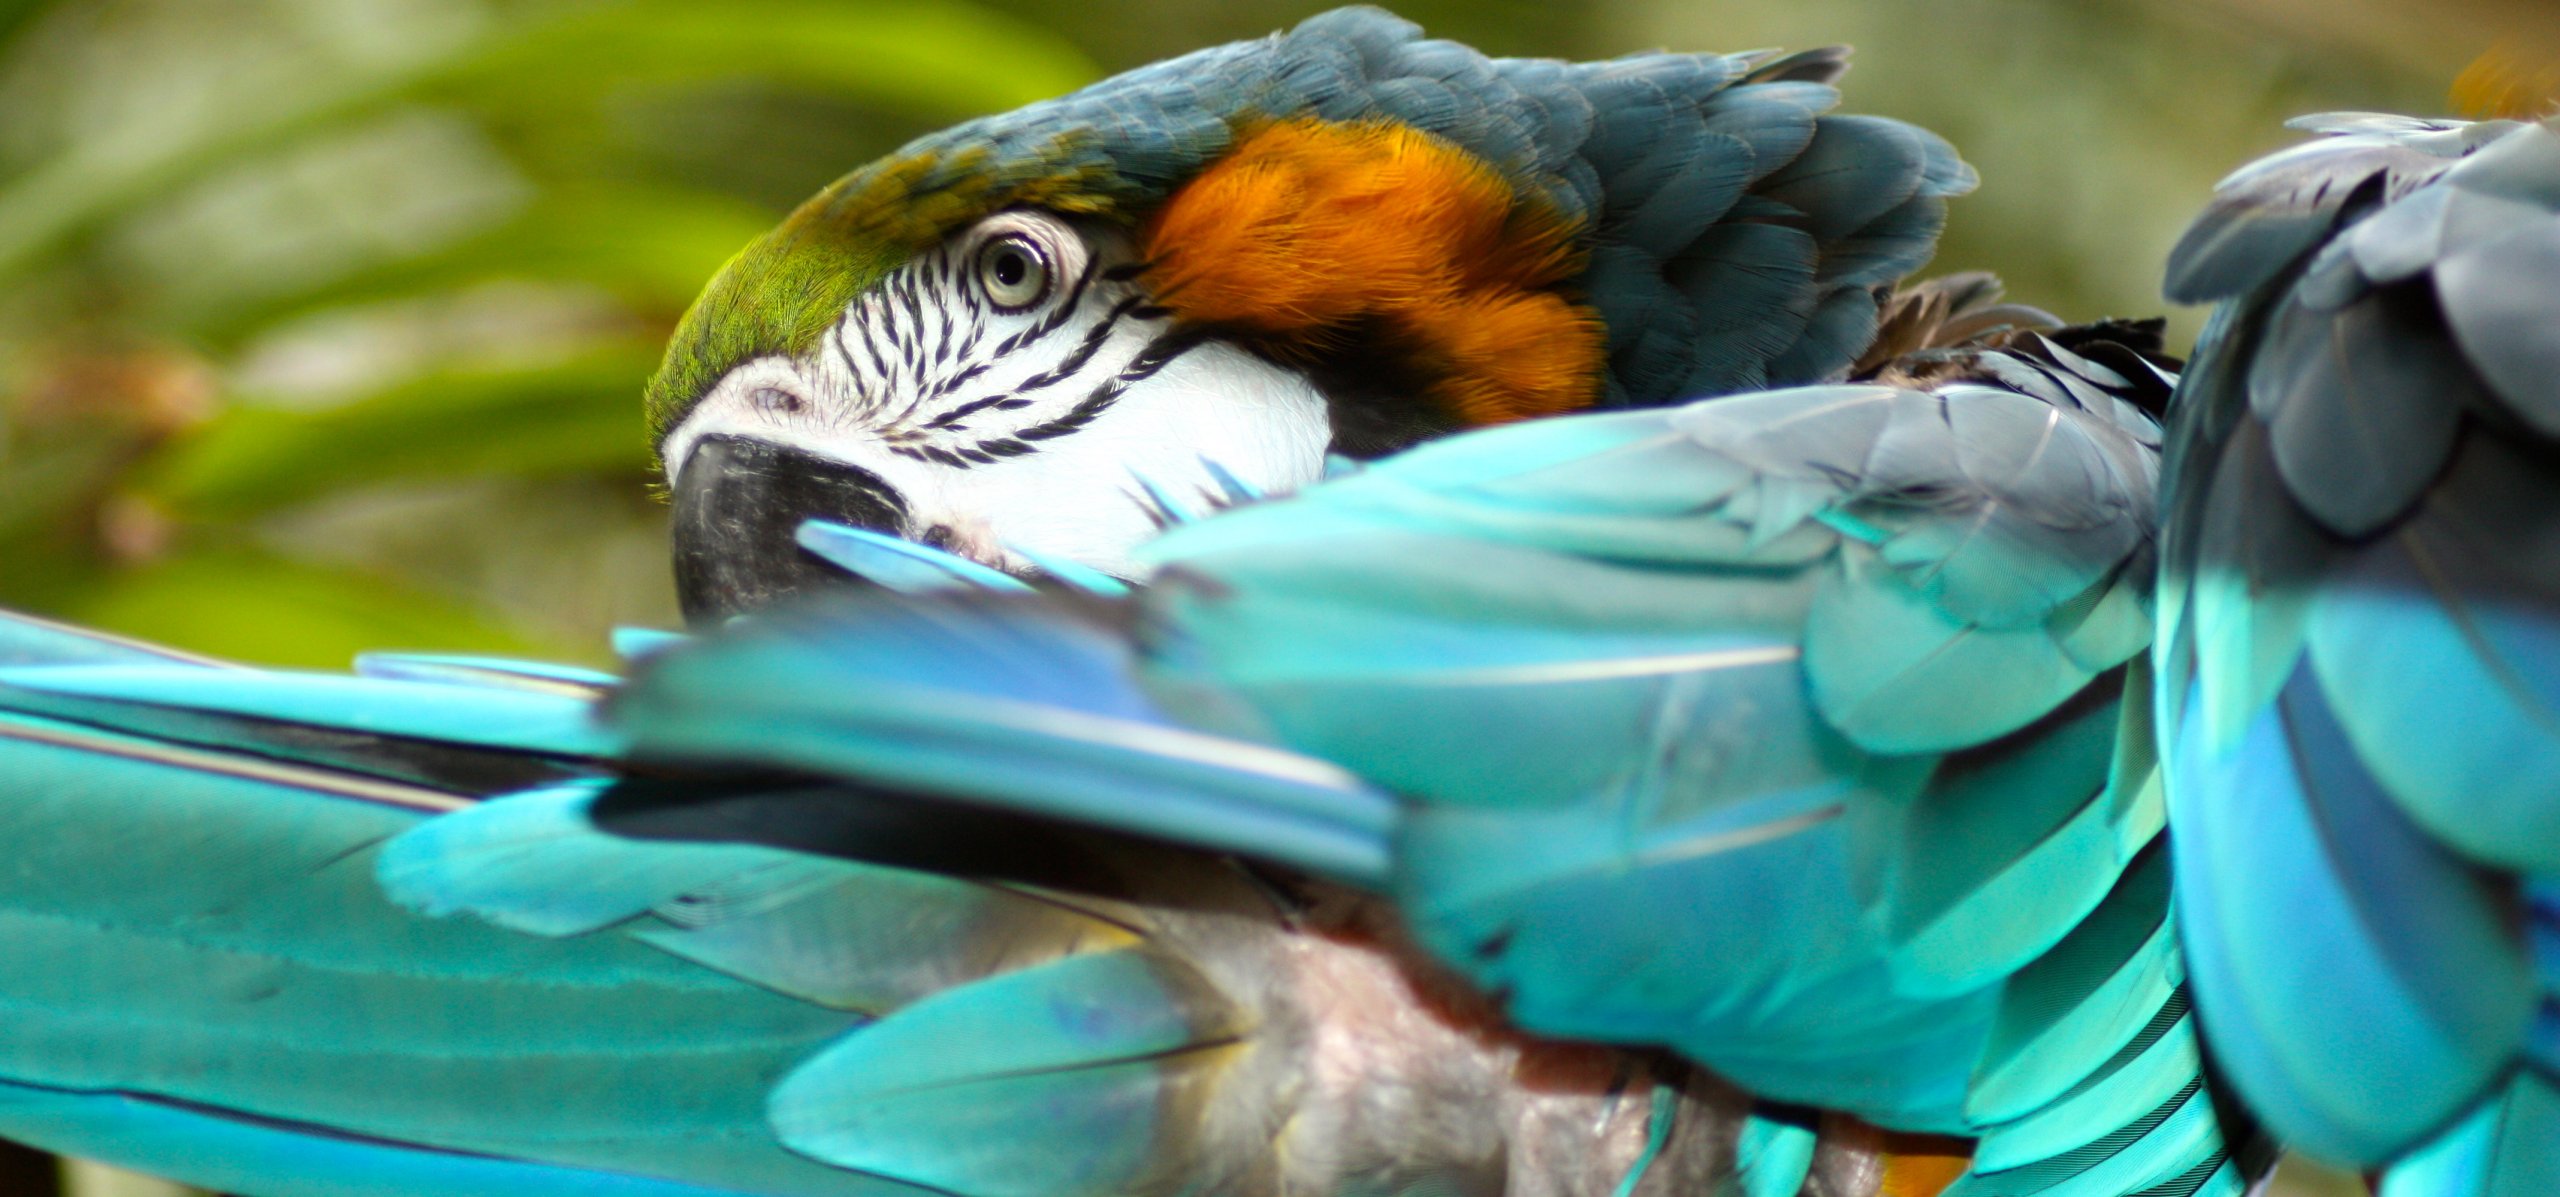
[614,593,1395,880]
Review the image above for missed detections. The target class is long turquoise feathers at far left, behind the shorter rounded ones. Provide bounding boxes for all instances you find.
[0,665,901,1197]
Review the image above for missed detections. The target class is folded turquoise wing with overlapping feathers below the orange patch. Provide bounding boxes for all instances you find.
[1111,337,2225,1179]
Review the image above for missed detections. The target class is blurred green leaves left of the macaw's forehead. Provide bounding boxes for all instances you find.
[0,0,1096,665]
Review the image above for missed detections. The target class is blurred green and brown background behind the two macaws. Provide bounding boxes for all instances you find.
[0,0,2560,1194]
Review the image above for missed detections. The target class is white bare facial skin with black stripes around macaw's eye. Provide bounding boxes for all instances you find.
[660,210,1331,578]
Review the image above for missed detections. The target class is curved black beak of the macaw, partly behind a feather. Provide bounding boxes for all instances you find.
[676,437,906,627]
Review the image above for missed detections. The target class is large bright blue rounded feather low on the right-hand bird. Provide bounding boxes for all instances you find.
[2171,670,2534,1161]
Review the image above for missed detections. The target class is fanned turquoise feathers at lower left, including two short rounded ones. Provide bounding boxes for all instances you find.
[0,622,1262,1197]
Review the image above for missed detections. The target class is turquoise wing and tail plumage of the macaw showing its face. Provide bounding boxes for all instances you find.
[0,345,2255,1194]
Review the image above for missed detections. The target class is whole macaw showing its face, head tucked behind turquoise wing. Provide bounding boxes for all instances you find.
[0,10,2268,1197]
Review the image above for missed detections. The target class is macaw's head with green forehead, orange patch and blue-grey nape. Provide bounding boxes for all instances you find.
[648,8,1971,619]
